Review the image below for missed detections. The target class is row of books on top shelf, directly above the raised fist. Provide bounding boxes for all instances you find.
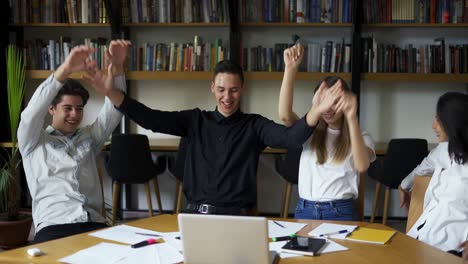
[239,0,353,23]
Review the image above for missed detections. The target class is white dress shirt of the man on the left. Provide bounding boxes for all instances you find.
[18,75,126,232]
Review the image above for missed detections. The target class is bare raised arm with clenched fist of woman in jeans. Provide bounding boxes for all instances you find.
[278,44,304,127]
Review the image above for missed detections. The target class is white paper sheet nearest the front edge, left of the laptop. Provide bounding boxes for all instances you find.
[59,242,132,264]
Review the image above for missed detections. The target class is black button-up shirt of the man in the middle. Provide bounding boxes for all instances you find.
[119,96,313,208]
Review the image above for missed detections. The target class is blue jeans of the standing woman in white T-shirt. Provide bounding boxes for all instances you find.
[294,198,357,221]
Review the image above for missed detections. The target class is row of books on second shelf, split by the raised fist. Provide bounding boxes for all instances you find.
[241,40,351,72]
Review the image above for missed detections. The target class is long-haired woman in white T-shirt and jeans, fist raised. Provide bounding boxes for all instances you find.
[279,44,375,220]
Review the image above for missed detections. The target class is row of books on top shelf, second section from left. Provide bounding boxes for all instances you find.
[121,0,229,23]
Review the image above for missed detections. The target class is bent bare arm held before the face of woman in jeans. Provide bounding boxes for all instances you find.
[336,89,375,172]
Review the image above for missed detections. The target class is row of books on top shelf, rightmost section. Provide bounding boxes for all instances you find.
[362,0,468,24]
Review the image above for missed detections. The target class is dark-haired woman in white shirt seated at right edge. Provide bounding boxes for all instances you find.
[400,92,468,255]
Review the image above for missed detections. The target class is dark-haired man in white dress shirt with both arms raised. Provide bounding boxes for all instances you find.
[18,40,129,242]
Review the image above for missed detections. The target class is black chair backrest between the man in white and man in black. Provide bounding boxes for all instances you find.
[107,134,158,183]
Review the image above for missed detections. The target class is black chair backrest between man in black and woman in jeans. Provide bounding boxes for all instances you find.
[275,145,302,184]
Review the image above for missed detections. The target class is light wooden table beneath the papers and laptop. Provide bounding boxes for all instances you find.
[0,215,463,264]
